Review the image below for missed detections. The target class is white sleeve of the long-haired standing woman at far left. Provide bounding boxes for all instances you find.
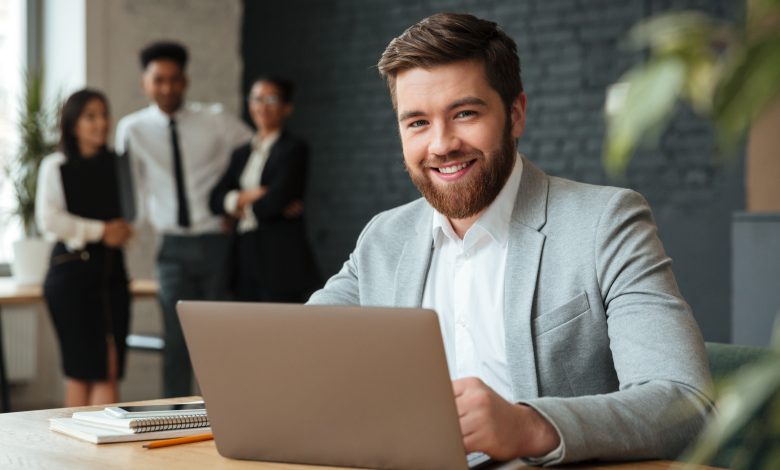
[35,152,105,251]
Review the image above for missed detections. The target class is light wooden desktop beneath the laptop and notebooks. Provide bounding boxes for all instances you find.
[0,397,724,470]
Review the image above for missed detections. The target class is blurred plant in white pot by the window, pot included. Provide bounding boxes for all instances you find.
[6,72,56,284]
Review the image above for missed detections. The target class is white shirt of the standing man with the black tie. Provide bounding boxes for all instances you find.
[116,103,252,235]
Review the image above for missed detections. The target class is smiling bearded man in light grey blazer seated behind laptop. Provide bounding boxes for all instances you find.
[309,13,712,464]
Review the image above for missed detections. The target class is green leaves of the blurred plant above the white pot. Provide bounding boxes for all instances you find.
[5,71,57,237]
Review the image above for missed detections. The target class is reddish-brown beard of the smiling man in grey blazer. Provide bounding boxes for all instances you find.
[404,128,515,219]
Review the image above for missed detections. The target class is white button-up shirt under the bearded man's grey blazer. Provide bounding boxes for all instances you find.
[422,156,523,402]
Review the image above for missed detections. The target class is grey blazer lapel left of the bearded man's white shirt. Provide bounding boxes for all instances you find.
[394,204,433,307]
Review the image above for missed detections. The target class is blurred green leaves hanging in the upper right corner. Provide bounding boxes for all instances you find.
[604,0,780,176]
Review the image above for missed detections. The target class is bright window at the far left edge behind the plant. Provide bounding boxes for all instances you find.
[0,0,26,265]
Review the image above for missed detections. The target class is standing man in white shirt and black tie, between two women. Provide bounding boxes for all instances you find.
[116,42,252,397]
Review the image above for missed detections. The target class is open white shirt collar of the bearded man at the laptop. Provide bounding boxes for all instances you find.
[431,153,523,250]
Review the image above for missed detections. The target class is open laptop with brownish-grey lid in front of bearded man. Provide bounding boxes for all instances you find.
[177,301,500,470]
